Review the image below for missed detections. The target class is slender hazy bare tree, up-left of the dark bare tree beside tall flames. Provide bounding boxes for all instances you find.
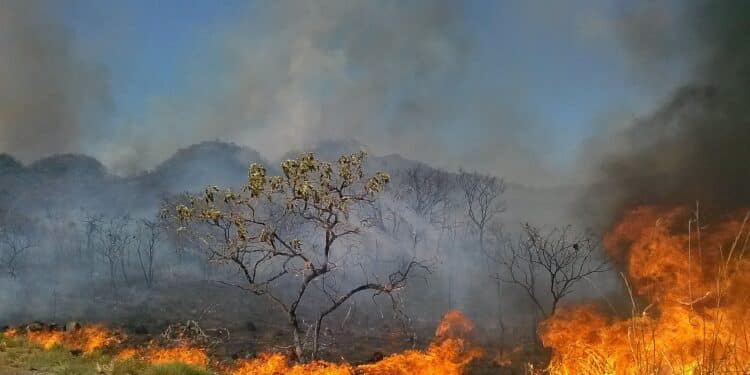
[458,170,505,252]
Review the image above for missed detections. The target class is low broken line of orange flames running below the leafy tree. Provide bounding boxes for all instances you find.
[3,311,482,375]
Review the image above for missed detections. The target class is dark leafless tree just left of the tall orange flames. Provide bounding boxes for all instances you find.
[497,224,608,318]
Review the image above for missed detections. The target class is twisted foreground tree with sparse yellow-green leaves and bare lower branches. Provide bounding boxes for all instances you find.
[176,152,425,361]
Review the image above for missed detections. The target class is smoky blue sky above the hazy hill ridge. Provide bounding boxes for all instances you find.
[0,0,687,186]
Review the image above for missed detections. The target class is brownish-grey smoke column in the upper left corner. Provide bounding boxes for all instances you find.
[0,0,109,161]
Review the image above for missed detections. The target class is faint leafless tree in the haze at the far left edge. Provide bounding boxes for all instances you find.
[0,211,36,278]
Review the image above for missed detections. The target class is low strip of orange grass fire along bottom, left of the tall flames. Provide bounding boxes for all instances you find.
[0,311,481,375]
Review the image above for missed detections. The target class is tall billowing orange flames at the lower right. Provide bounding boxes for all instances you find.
[540,207,750,375]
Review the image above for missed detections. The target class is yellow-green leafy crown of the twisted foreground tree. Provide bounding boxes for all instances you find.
[175,152,390,260]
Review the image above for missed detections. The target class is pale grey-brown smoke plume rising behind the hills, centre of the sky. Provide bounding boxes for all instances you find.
[102,0,469,172]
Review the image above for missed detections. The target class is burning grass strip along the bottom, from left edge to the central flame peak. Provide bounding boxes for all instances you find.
[0,311,481,375]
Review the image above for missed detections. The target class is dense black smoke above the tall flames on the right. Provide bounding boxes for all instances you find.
[600,1,750,222]
